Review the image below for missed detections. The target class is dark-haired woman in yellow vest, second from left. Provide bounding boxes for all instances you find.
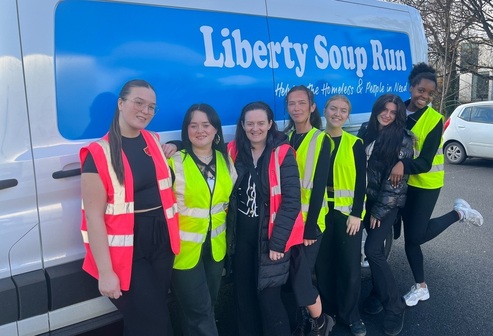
[169,104,236,336]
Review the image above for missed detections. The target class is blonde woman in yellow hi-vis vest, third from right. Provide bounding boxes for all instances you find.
[316,95,366,336]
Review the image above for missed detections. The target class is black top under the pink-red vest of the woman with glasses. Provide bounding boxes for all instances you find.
[82,133,162,210]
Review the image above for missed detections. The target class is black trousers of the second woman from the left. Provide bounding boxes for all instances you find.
[172,235,224,336]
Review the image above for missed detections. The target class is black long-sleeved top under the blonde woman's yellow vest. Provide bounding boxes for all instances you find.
[327,136,366,218]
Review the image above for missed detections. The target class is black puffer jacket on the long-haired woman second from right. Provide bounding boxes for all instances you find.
[362,123,414,219]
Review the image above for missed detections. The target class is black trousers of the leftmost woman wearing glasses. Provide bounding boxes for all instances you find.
[111,209,175,336]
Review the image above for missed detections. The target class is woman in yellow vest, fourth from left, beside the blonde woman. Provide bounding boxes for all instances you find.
[285,85,334,336]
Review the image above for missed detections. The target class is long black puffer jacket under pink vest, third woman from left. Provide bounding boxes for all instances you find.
[226,132,301,291]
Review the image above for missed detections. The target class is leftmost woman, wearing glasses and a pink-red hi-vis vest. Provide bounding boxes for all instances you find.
[80,79,180,336]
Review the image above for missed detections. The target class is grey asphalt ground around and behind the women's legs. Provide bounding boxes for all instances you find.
[217,159,493,336]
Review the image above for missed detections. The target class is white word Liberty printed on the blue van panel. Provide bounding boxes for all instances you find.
[200,26,308,77]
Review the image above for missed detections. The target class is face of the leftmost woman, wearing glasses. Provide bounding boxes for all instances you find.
[118,87,156,138]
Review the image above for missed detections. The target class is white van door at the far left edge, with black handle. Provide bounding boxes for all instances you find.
[0,1,48,335]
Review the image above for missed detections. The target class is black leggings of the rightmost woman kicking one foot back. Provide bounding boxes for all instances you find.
[402,186,460,283]
